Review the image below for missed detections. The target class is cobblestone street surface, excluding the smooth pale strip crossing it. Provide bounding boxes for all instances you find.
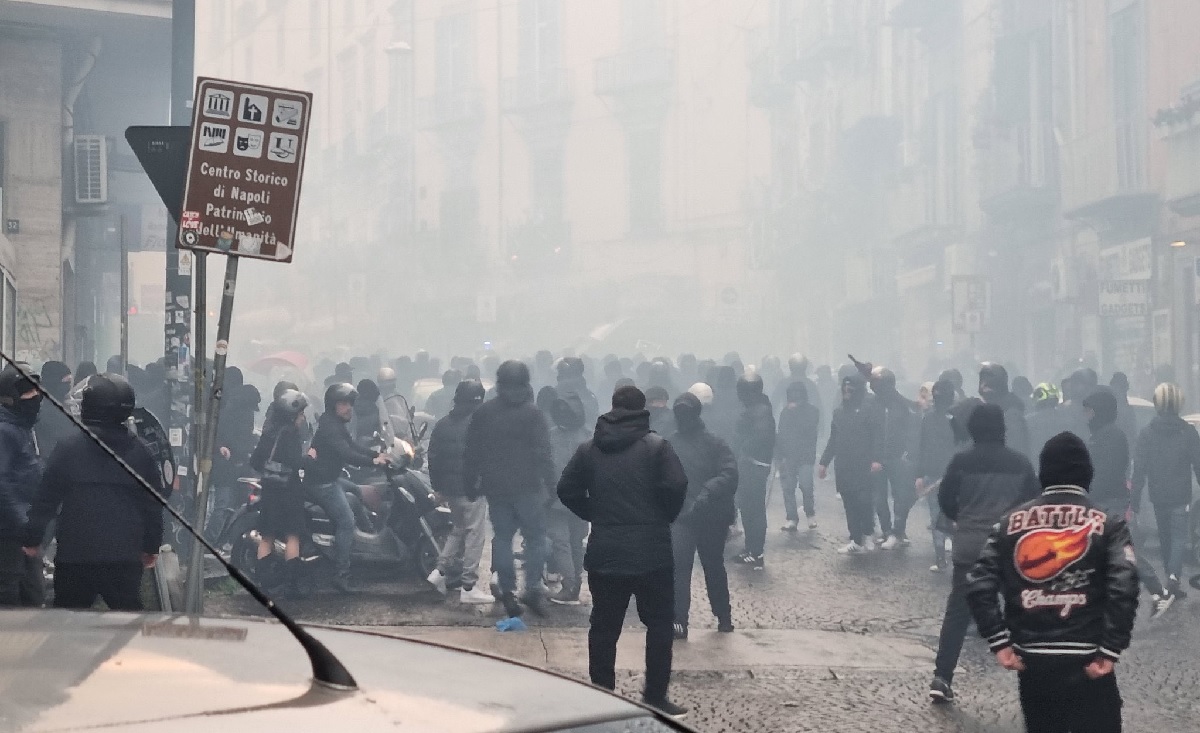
[209,482,1200,733]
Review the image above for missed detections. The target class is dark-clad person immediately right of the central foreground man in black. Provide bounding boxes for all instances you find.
[671,392,734,639]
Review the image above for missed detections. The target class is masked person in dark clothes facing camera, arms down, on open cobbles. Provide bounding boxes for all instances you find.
[817,371,883,554]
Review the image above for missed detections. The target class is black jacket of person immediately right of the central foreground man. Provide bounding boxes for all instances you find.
[671,399,738,531]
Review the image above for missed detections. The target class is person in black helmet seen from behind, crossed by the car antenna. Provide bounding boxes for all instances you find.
[22,374,163,611]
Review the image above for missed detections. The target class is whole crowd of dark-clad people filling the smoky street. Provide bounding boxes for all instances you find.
[0,352,1180,729]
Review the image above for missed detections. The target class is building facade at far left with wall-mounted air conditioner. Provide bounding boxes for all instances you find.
[0,0,170,364]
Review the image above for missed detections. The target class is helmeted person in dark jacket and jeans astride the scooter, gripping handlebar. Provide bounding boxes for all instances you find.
[305,384,388,593]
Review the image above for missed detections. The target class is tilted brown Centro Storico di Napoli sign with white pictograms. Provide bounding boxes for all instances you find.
[178,77,312,263]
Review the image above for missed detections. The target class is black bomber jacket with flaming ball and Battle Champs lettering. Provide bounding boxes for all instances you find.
[967,486,1138,661]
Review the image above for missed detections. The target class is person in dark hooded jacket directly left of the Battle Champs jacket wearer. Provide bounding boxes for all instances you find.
[929,404,1042,703]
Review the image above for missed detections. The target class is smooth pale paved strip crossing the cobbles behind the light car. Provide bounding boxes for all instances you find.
[358,626,934,672]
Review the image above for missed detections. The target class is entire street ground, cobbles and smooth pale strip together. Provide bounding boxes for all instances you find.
[209,482,1200,733]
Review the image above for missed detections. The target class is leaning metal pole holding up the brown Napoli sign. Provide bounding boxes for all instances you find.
[187,256,238,615]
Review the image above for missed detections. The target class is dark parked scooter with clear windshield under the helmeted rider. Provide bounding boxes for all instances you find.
[217,439,452,585]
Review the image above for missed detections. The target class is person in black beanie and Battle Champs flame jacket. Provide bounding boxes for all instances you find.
[966,432,1138,733]
